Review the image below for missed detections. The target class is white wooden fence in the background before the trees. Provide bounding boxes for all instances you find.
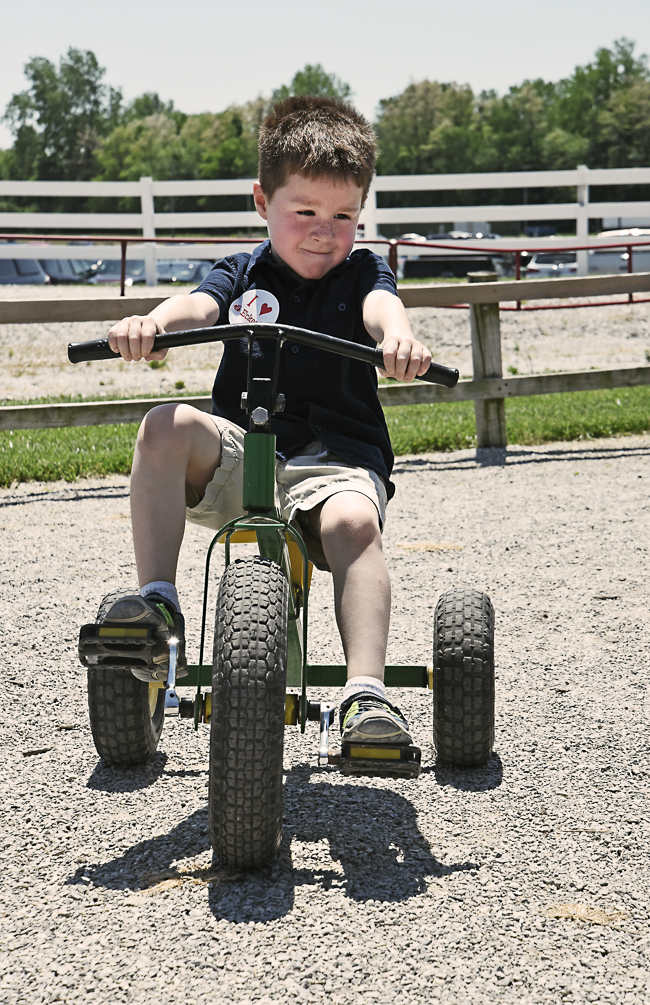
[0,166,650,285]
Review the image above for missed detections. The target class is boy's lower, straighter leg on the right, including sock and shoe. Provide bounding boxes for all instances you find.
[309,491,412,744]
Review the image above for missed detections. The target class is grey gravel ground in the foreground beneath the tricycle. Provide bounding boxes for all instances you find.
[0,436,650,1005]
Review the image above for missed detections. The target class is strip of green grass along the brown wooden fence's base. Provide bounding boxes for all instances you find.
[0,387,650,486]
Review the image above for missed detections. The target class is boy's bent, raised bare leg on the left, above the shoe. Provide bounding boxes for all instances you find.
[131,405,221,587]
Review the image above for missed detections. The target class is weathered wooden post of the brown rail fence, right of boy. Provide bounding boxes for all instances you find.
[467,272,507,449]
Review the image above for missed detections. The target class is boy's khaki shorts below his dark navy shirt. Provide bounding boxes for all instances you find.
[185,415,388,570]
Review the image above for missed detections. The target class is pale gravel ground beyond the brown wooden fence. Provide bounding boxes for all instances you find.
[0,286,650,401]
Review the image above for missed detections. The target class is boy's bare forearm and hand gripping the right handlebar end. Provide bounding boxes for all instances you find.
[362,289,431,381]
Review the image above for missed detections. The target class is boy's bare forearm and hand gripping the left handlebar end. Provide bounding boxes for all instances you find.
[109,293,219,360]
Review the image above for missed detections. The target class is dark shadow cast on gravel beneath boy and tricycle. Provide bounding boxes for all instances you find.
[72,765,479,923]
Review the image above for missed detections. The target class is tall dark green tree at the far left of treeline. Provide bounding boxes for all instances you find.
[4,47,122,181]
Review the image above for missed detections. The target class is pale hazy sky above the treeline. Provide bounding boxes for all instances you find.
[0,0,650,148]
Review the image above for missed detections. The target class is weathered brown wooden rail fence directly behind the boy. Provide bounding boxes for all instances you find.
[0,272,650,447]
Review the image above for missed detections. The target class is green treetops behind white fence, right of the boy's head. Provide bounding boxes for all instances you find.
[376,39,650,176]
